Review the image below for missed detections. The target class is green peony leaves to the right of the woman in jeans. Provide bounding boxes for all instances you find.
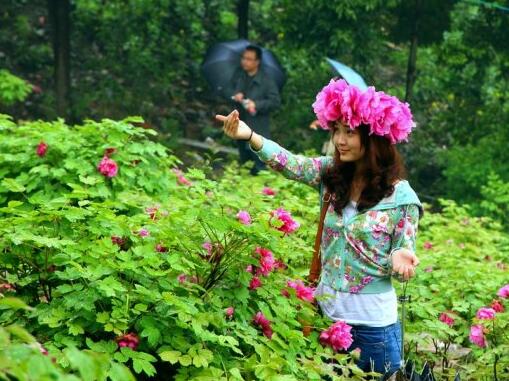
[400,200,509,380]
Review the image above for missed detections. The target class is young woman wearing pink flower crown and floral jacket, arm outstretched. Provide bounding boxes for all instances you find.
[216,80,422,379]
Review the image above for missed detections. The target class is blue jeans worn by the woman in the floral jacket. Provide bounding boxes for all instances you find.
[348,321,402,380]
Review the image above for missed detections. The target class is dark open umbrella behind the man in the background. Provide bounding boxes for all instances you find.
[201,40,286,92]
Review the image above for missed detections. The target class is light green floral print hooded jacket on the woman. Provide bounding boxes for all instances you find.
[250,139,422,294]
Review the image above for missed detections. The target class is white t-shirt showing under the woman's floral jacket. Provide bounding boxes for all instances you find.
[315,201,398,327]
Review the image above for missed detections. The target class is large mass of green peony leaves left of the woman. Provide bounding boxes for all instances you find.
[0,117,366,380]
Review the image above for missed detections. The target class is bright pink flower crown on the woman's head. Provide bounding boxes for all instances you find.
[313,79,415,144]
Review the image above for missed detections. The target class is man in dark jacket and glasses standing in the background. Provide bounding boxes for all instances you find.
[222,45,281,175]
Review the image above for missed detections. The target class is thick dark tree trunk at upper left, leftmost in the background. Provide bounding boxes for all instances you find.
[48,0,71,118]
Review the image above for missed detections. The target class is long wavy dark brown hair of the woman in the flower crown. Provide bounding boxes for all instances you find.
[323,125,406,214]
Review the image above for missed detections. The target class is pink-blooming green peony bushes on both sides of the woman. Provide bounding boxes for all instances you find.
[0,116,509,380]
